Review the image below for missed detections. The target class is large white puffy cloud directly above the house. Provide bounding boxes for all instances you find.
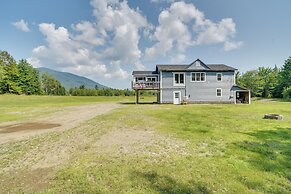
[145,1,242,60]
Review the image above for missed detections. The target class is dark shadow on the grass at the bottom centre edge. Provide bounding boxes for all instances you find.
[132,171,212,194]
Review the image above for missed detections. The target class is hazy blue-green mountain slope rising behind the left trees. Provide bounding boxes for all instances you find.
[37,67,108,90]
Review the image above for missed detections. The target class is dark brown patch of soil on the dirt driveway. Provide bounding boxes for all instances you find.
[0,123,61,133]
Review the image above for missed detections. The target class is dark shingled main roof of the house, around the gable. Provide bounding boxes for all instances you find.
[157,64,237,71]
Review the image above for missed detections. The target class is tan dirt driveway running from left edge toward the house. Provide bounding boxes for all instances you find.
[0,103,120,144]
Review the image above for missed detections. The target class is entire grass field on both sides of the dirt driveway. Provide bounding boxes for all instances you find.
[0,96,291,193]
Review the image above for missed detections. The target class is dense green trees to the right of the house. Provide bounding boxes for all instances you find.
[236,57,291,100]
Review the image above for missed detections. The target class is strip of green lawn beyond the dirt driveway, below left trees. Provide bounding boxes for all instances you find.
[0,95,134,122]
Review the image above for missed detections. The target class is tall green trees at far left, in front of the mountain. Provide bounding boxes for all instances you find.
[0,51,66,95]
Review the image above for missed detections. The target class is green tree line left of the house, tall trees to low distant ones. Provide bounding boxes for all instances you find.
[0,51,135,96]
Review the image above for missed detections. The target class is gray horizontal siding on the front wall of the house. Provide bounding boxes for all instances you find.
[161,72,234,103]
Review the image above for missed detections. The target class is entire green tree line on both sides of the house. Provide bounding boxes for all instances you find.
[0,51,291,100]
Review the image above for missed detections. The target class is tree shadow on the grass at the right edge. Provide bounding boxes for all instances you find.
[234,128,291,181]
